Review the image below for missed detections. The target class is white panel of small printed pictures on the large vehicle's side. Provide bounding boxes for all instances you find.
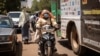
[60,0,81,18]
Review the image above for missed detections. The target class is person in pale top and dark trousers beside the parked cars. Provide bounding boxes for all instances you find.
[18,7,29,43]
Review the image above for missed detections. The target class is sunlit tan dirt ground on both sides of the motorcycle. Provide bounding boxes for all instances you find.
[18,34,75,56]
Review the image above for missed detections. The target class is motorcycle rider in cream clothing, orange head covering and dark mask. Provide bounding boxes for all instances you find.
[34,9,58,51]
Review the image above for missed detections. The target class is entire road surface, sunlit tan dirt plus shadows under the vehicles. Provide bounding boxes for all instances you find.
[0,34,100,56]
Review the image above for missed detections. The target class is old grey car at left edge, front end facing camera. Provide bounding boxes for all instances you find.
[0,15,17,54]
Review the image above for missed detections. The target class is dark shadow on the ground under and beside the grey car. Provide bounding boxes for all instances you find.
[0,42,23,56]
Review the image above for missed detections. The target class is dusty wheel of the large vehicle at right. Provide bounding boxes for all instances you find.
[71,26,85,55]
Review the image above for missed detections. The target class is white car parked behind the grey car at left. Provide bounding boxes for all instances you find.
[7,11,21,29]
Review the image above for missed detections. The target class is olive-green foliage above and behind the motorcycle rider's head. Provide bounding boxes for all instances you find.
[31,0,51,12]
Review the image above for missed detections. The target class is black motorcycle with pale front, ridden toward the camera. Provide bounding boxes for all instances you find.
[39,25,55,56]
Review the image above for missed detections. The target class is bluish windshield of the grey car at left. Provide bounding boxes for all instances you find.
[0,17,12,28]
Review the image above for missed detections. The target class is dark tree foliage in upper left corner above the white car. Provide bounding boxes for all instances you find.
[0,0,20,14]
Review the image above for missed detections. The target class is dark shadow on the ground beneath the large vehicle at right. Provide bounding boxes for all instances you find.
[58,39,100,56]
